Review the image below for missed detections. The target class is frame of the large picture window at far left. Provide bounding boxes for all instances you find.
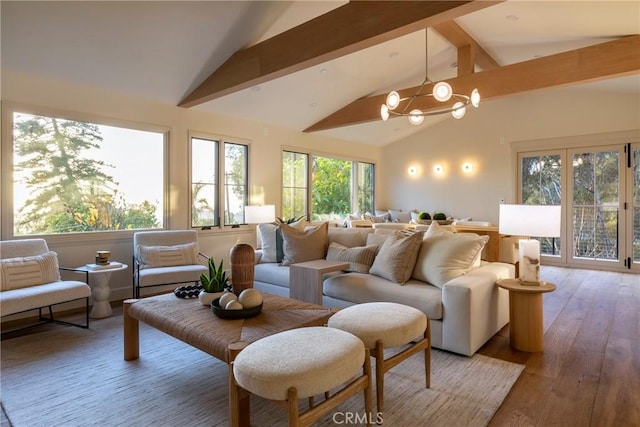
[0,101,172,244]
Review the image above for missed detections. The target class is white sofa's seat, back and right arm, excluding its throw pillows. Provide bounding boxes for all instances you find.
[254,227,515,356]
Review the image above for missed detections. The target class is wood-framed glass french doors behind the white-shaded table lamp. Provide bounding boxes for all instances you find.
[518,143,640,272]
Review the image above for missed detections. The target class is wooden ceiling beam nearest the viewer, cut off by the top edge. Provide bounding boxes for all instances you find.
[178,0,504,107]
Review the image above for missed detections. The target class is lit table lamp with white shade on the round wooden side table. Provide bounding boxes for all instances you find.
[498,205,560,285]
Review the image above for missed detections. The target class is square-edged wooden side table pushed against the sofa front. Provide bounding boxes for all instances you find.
[289,259,351,305]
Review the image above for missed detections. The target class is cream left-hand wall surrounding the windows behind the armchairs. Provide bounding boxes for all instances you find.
[2,70,381,300]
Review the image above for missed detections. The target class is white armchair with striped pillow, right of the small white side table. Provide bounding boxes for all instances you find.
[133,230,209,298]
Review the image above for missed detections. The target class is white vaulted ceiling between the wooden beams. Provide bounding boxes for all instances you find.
[1,0,640,146]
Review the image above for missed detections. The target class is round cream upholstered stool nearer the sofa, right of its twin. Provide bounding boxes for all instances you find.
[328,302,431,414]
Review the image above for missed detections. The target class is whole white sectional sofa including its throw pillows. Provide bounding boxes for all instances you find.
[254,223,515,356]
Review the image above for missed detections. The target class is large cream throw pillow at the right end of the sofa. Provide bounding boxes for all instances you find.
[413,233,489,288]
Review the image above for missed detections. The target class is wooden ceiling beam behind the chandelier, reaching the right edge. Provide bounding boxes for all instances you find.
[304,35,640,132]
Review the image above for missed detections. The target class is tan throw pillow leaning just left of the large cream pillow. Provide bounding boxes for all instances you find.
[369,231,424,285]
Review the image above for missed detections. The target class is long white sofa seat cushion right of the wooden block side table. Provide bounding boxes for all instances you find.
[323,273,443,320]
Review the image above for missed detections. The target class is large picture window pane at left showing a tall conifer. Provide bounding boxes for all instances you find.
[10,110,167,236]
